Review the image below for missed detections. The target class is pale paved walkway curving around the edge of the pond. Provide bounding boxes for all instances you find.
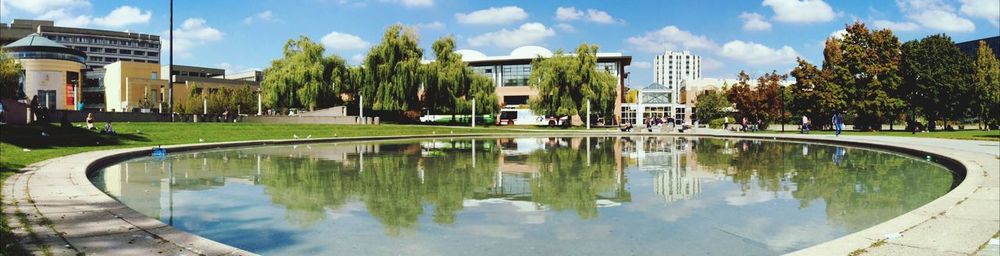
[3,129,1000,255]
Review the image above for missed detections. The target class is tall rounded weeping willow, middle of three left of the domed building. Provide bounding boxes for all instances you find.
[357,24,424,111]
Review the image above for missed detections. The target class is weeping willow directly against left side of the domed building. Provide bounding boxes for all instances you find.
[423,37,500,114]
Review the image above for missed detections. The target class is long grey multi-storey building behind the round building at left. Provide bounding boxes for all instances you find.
[0,19,161,109]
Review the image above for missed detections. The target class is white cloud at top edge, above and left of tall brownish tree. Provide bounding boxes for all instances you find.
[761,0,837,23]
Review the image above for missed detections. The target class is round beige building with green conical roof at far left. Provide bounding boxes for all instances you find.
[3,34,87,109]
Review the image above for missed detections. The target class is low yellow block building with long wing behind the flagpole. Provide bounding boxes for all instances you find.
[103,61,260,112]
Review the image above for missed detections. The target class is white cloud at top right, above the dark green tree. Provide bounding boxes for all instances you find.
[896,0,976,32]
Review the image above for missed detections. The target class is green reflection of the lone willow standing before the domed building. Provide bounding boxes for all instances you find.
[528,138,631,219]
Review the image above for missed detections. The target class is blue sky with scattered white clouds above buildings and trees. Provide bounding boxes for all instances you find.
[0,0,1000,87]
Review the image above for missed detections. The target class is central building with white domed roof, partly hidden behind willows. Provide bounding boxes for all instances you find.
[457,46,632,123]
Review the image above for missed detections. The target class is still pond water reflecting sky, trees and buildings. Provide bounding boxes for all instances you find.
[92,137,955,255]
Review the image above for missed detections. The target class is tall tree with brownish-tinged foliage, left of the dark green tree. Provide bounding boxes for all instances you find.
[835,22,903,130]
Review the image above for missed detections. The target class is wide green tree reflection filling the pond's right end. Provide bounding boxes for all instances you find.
[694,139,953,232]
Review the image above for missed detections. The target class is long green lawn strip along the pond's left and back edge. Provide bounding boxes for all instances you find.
[0,123,561,171]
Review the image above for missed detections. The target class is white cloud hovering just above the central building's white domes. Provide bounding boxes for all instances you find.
[468,22,556,48]
